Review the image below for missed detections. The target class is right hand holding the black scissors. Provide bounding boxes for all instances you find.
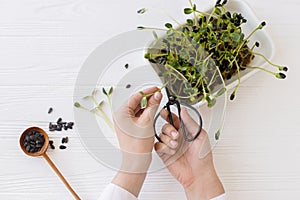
[155,108,224,200]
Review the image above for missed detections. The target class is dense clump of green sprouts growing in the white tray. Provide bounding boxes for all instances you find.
[138,0,288,140]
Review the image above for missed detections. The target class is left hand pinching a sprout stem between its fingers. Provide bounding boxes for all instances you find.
[114,87,162,173]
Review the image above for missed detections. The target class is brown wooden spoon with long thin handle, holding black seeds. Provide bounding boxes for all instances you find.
[20,127,80,200]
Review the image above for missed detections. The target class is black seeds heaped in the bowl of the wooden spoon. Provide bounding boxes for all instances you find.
[23,130,45,153]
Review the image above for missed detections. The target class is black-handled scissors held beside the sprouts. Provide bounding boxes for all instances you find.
[153,87,202,142]
